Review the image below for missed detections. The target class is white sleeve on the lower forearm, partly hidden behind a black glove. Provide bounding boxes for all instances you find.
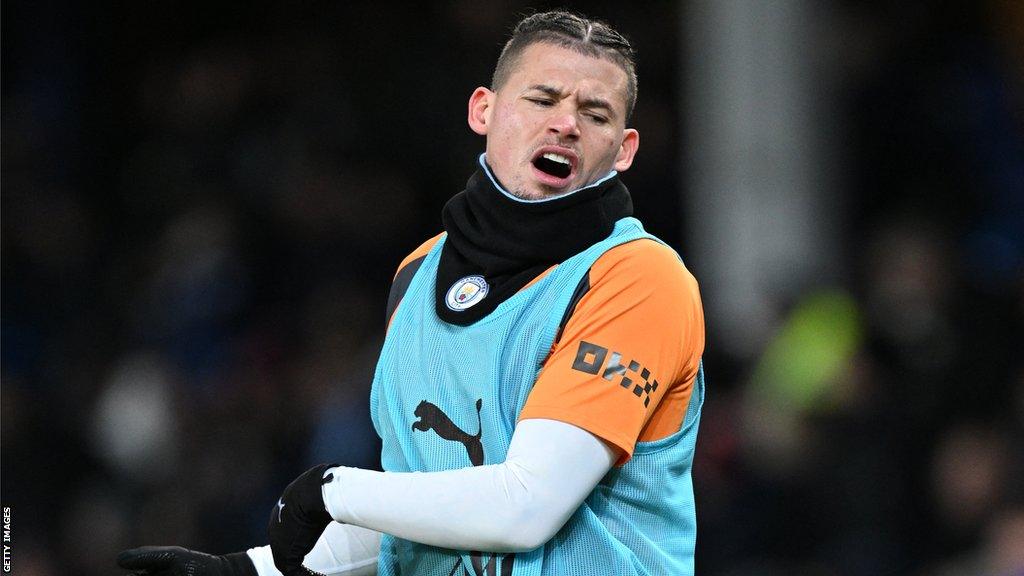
[247,522,381,576]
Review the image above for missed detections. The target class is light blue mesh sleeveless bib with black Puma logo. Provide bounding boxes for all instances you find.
[371,217,703,576]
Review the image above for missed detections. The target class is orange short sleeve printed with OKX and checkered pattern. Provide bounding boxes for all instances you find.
[519,235,705,465]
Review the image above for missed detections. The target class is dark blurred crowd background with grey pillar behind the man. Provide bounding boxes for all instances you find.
[0,0,1024,576]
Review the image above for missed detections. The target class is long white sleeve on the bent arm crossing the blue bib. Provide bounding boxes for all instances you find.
[324,419,616,552]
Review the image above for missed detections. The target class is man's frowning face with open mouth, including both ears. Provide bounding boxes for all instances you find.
[469,43,640,200]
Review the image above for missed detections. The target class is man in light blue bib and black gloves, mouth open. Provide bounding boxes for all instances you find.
[119,12,703,576]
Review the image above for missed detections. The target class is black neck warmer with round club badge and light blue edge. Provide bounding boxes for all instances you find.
[435,162,633,326]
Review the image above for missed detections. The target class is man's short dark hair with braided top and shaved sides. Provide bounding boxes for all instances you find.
[490,10,637,122]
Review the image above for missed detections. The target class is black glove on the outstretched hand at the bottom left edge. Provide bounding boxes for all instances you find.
[118,546,258,576]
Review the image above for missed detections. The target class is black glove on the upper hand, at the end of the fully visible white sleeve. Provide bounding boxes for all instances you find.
[267,464,338,576]
